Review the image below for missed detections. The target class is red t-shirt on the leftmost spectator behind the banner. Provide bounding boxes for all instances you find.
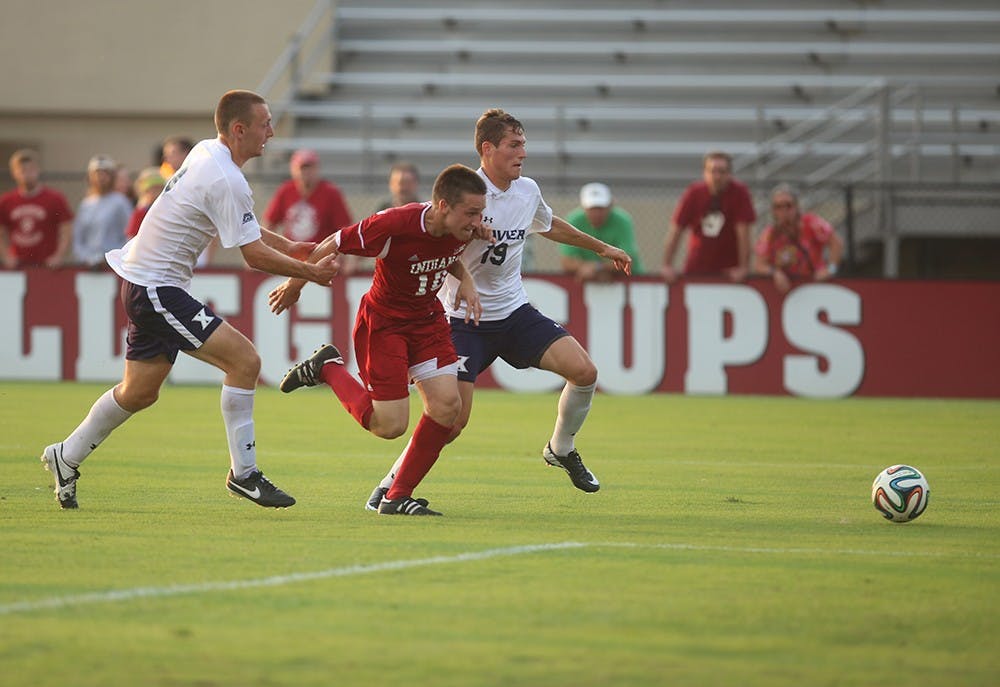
[0,186,73,265]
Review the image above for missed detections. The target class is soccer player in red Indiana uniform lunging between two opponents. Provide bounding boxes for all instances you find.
[268,165,486,515]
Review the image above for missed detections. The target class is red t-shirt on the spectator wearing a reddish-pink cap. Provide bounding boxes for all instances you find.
[264,179,353,243]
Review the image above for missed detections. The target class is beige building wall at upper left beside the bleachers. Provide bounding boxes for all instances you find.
[0,0,315,178]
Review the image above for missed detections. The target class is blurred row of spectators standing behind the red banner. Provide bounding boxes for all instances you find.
[0,142,844,293]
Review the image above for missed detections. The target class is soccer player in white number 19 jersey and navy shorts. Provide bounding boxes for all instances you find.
[365,109,632,510]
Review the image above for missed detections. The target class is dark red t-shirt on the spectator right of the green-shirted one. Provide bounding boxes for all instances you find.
[673,179,757,274]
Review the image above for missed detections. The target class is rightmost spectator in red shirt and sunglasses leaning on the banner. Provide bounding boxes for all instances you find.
[754,184,844,293]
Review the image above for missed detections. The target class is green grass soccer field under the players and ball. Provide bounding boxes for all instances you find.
[0,384,1000,687]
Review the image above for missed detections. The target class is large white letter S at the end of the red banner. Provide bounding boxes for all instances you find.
[781,284,865,398]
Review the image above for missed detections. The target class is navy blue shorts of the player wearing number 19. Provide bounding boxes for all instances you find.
[450,303,569,382]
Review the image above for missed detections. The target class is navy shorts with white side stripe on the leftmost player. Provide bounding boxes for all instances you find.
[122,280,222,363]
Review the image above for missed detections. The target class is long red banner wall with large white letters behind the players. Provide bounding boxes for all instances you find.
[0,268,1000,398]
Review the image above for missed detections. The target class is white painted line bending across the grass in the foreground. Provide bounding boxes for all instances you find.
[0,542,1000,615]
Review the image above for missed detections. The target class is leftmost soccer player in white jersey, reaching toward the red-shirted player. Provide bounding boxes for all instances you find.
[41,91,337,508]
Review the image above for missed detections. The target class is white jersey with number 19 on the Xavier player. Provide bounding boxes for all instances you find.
[438,168,552,321]
